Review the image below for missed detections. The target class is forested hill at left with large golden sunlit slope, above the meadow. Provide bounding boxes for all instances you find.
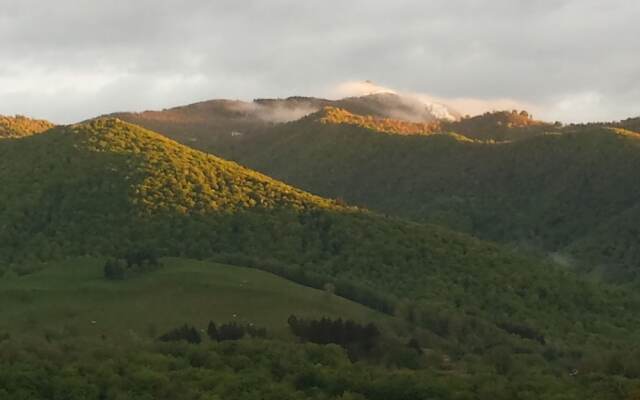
[0,119,576,313]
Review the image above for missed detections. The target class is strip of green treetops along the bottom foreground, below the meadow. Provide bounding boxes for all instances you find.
[0,337,640,400]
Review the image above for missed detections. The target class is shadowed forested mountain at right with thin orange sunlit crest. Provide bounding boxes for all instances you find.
[194,109,640,281]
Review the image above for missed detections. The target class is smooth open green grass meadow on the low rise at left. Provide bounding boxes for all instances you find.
[0,258,389,337]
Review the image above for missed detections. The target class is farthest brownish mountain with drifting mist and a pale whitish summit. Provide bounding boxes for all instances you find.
[109,93,459,150]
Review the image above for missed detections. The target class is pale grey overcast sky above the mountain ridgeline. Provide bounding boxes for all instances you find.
[0,0,640,123]
